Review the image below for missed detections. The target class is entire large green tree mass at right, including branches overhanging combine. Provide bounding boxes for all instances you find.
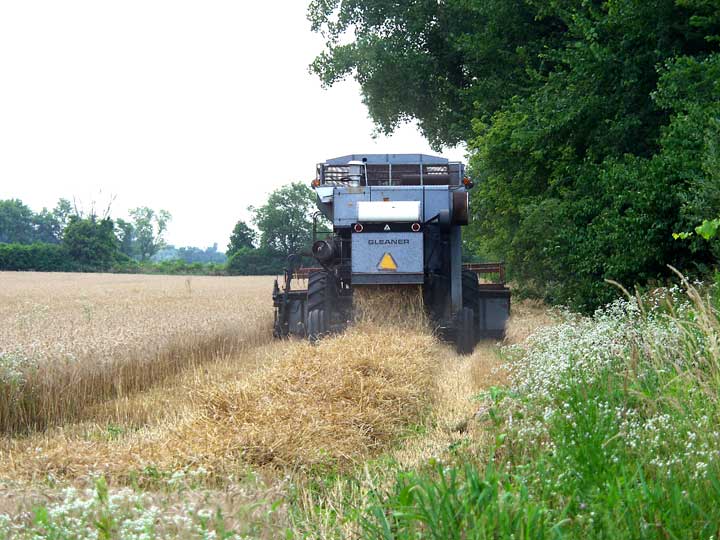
[309,0,720,311]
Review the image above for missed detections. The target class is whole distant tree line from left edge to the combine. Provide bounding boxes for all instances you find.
[0,183,315,275]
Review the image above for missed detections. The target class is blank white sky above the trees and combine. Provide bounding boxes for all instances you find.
[0,0,464,250]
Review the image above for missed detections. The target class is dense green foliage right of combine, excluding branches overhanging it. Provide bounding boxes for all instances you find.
[470,0,720,312]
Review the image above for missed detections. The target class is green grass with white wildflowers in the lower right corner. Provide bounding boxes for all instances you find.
[361,280,720,539]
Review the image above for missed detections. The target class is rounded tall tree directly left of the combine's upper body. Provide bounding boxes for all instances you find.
[250,182,315,255]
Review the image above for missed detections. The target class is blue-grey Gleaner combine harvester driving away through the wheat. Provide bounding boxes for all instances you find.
[273,154,510,354]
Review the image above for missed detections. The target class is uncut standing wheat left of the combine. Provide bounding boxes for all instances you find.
[0,272,272,432]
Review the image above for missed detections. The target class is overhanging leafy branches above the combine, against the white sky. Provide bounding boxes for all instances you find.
[308,0,562,147]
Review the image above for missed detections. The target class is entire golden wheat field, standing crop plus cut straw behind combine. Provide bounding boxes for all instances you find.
[0,273,547,537]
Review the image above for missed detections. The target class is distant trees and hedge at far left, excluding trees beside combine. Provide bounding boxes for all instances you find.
[0,199,226,273]
